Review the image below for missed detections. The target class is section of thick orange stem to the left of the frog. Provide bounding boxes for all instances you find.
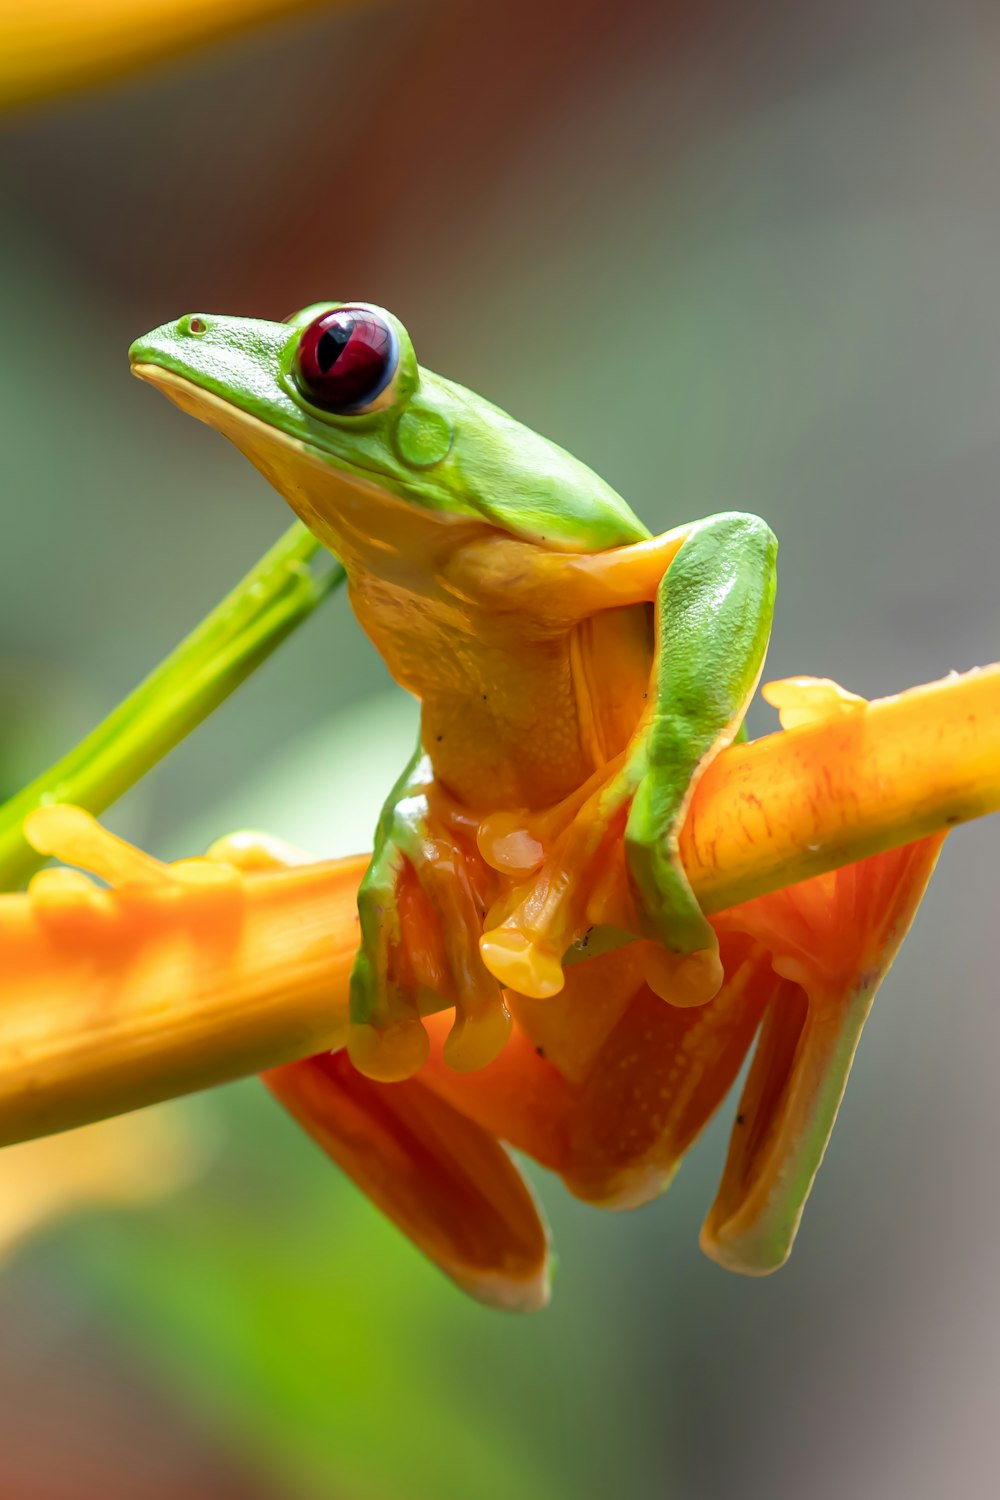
[0,857,367,1146]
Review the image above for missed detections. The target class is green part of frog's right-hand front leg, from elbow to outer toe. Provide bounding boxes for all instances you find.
[622,512,778,972]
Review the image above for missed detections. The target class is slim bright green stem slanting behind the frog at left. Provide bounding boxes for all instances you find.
[0,522,345,890]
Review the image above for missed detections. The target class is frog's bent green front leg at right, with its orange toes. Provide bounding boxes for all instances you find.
[483,512,777,1004]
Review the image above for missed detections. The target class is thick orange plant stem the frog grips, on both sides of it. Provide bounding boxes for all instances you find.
[0,665,1000,1145]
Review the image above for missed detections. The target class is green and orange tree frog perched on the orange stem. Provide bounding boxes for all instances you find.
[130,303,933,1290]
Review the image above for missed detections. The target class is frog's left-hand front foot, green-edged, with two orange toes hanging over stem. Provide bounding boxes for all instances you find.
[348,786,510,1082]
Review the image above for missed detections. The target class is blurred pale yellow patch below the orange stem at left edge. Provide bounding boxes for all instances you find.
[0,1110,204,1265]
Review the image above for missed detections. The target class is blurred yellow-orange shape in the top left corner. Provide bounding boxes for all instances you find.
[0,0,371,107]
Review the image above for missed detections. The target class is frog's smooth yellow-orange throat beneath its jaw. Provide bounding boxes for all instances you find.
[132,362,484,570]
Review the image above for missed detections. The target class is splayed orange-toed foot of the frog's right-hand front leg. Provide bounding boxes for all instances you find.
[478,762,723,1007]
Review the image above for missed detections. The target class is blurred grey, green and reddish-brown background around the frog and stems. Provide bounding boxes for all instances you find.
[0,0,1000,1500]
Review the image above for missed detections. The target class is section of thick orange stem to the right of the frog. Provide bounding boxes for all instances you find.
[681,663,1000,912]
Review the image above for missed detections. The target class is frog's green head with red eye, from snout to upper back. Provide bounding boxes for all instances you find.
[129,303,648,552]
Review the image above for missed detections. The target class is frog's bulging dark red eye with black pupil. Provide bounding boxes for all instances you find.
[295,308,399,414]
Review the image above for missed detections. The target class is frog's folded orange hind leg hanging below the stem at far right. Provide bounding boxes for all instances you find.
[702,834,945,1275]
